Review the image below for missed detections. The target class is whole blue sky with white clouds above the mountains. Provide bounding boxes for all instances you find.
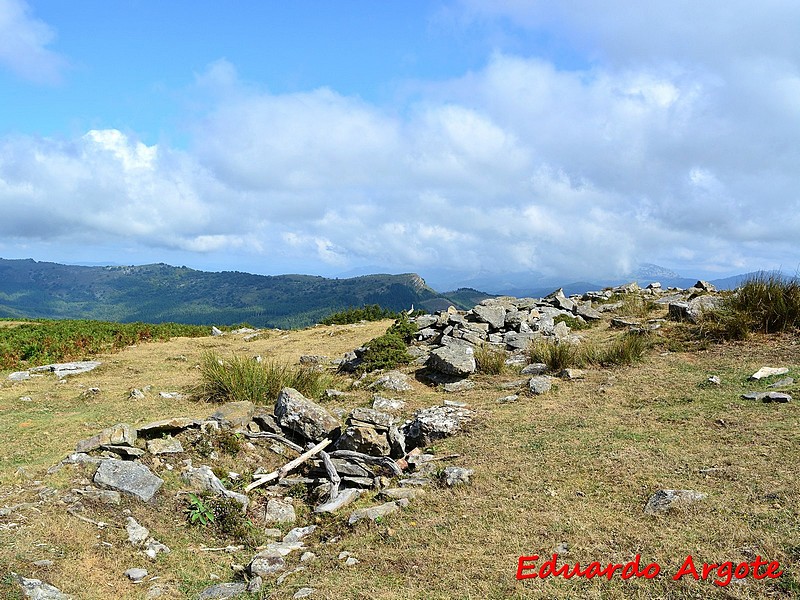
[0,0,800,291]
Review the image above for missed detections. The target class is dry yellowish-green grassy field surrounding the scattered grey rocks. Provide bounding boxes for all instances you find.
[0,315,800,600]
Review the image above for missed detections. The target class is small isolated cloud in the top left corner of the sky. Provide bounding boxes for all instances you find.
[0,0,67,83]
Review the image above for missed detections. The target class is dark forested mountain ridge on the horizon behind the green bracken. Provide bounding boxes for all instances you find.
[0,259,489,328]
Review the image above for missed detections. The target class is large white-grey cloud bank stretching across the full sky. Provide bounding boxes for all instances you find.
[0,0,800,278]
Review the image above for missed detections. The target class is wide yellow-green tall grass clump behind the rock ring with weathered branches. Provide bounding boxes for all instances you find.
[194,352,333,404]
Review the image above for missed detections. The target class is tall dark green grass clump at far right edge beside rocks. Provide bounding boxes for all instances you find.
[701,273,800,339]
